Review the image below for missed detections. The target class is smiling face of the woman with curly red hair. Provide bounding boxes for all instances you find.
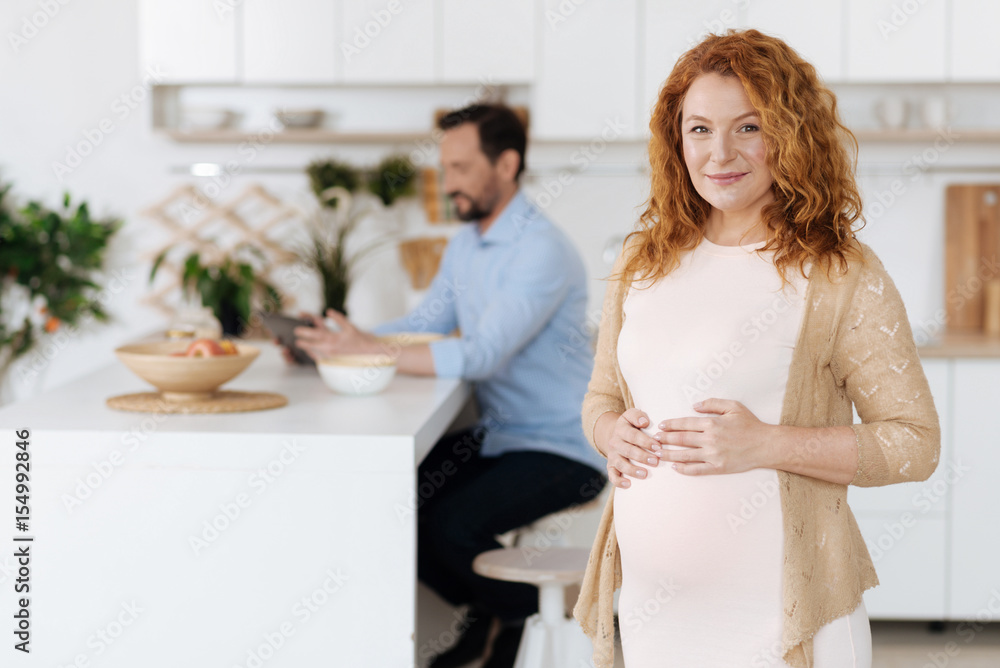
[681,74,774,220]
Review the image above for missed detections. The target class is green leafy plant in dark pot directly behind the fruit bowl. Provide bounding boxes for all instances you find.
[149,244,282,336]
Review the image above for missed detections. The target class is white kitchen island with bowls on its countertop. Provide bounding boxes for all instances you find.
[0,343,469,668]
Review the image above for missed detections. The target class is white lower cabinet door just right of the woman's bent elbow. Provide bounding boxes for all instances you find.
[847,358,955,512]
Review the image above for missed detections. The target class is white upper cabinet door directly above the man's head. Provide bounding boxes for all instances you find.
[442,0,536,84]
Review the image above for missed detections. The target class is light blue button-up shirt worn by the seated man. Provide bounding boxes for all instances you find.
[375,191,606,473]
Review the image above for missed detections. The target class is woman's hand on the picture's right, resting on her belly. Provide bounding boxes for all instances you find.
[653,398,775,475]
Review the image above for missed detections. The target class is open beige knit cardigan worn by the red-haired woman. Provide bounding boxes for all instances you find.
[573,242,941,668]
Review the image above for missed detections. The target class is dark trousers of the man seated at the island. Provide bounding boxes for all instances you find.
[417,429,607,622]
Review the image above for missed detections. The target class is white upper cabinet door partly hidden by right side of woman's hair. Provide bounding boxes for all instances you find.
[746,0,844,81]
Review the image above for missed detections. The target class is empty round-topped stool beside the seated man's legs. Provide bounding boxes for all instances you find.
[472,547,593,668]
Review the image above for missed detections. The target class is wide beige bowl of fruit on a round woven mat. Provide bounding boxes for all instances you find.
[115,339,260,401]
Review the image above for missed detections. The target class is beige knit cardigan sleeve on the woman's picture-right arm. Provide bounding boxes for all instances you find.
[831,247,941,487]
